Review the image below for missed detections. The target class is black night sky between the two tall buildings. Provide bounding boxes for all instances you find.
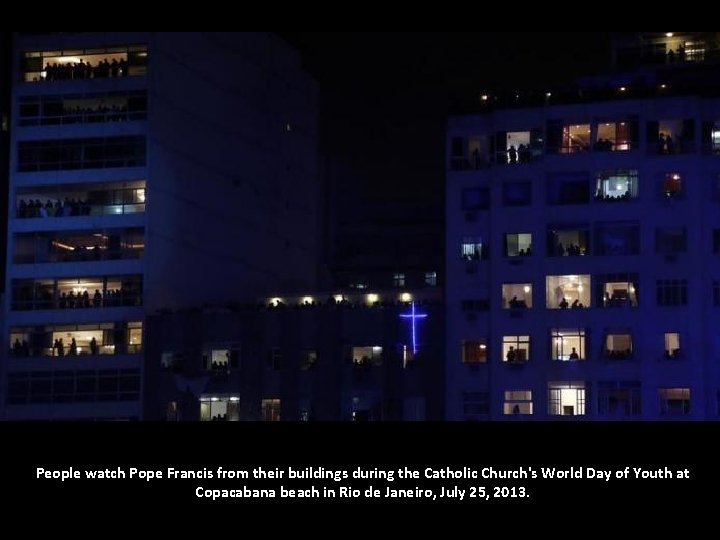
[280,32,610,204]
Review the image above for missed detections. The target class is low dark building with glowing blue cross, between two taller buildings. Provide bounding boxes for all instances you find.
[144,290,444,421]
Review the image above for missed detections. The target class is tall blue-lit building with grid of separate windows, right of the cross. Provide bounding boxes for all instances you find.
[446,32,720,420]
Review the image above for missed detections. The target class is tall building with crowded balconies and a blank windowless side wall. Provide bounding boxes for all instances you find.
[2,32,319,419]
